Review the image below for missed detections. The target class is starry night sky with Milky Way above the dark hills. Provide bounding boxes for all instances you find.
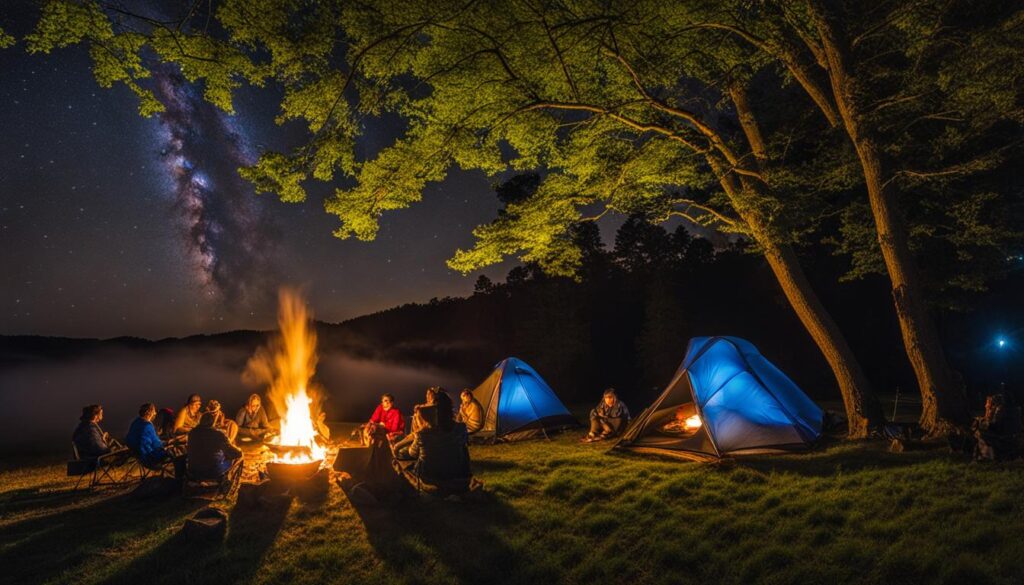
[0,3,511,338]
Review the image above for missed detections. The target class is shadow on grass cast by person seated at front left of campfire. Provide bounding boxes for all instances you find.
[105,493,289,585]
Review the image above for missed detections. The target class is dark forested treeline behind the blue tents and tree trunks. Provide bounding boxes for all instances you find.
[341,216,1021,413]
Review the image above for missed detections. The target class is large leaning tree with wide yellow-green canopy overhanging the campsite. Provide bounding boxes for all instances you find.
[29,0,883,436]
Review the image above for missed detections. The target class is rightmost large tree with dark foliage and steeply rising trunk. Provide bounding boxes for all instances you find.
[689,0,1024,434]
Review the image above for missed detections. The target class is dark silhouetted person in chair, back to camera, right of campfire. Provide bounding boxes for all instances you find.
[398,391,472,492]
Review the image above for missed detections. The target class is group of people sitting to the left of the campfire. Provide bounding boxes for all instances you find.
[72,394,284,480]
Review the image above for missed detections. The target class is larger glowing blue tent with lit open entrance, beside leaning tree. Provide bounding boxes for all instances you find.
[616,337,823,459]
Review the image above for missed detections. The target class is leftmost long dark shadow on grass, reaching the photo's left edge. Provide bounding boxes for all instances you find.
[0,492,205,583]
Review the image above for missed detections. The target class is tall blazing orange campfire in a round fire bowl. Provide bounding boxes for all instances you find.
[246,289,327,478]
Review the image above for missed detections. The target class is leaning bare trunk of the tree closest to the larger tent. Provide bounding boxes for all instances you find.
[709,158,885,438]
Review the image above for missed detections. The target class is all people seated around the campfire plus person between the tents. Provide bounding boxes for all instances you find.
[73,386,643,499]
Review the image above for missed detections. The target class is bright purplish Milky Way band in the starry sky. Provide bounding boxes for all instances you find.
[156,70,279,310]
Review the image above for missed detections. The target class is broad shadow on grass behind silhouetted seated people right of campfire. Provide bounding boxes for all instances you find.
[353,489,544,583]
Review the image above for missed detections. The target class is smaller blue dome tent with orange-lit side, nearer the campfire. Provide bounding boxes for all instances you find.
[473,358,579,441]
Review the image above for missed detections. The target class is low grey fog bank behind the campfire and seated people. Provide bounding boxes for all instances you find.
[0,348,468,452]
